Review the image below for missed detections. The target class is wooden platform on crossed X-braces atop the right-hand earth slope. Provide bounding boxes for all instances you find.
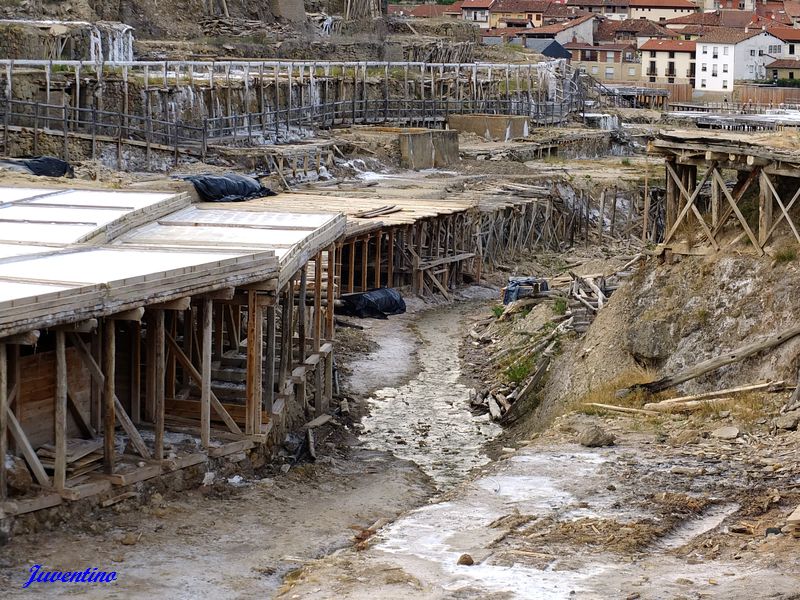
[650,130,800,255]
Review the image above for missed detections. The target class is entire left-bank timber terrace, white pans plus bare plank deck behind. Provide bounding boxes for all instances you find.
[0,170,580,519]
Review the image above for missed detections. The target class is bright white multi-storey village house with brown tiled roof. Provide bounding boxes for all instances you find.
[695,28,783,92]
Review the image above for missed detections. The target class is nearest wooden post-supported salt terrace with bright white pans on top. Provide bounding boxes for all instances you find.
[0,188,345,518]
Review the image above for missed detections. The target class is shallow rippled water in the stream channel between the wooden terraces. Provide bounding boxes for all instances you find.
[354,310,501,489]
